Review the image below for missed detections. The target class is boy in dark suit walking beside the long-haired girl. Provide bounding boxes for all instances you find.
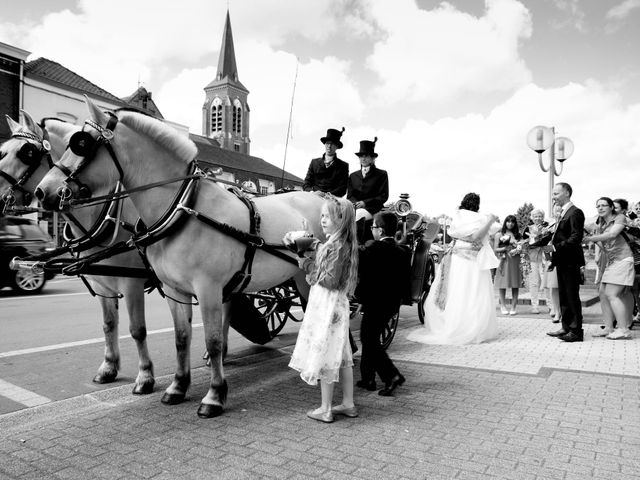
[356,212,411,397]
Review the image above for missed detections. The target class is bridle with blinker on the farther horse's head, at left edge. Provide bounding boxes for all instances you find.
[0,129,53,211]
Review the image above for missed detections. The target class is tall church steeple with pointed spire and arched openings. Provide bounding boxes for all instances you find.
[202,10,250,154]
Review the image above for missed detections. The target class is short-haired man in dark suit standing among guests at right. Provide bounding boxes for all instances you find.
[543,182,584,342]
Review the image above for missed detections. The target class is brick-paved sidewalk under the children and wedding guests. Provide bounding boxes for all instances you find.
[0,306,640,480]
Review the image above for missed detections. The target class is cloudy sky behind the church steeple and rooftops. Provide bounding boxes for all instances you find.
[0,0,640,218]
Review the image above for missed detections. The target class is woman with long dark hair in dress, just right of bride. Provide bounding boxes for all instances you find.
[493,215,522,315]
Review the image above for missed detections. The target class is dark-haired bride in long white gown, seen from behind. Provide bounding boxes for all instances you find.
[408,193,499,345]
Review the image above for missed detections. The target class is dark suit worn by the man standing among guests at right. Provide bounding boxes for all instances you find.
[551,205,584,337]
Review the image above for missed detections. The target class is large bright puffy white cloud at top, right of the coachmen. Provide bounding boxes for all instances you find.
[367,0,531,102]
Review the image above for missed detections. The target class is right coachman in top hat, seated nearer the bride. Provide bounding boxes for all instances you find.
[347,137,389,242]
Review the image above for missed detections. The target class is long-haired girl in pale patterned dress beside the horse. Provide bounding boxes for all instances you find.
[284,195,358,423]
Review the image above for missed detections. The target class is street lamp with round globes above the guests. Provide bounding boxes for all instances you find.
[527,125,573,215]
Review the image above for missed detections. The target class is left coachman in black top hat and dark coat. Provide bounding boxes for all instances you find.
[302,127,349,197]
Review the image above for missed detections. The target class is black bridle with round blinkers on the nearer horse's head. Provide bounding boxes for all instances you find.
[53,112,124,205]
